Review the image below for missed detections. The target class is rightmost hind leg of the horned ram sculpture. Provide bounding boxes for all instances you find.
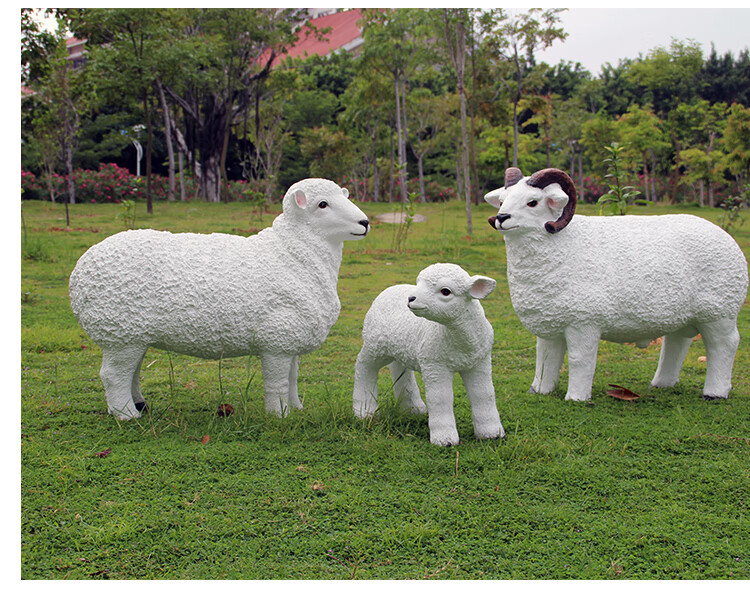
[699,318,740,399]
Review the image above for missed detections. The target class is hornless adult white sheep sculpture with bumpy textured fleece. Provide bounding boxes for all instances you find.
[70,178,370,420]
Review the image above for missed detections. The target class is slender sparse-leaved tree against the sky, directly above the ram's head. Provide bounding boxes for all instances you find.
[480,8,568,166]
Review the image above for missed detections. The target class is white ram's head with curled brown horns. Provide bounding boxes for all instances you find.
[484,168,576,234]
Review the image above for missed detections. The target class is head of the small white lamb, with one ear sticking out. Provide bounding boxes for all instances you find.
[408,263,495,324]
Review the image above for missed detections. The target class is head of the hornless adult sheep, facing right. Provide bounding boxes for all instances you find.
[283,178,370,242]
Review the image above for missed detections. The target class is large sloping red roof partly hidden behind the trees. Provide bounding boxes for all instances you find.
[276,8,362,64]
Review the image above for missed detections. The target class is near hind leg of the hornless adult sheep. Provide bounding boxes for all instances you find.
[99,345,148,420]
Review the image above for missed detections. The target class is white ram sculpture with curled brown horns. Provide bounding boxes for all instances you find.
[485,168,748,401]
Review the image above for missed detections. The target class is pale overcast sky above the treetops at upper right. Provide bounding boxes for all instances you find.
[536,8,750,77]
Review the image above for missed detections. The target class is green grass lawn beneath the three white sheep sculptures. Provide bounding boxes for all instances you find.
[21,202,750,579]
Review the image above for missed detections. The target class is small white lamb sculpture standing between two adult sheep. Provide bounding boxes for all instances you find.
[353,263,505,446]
